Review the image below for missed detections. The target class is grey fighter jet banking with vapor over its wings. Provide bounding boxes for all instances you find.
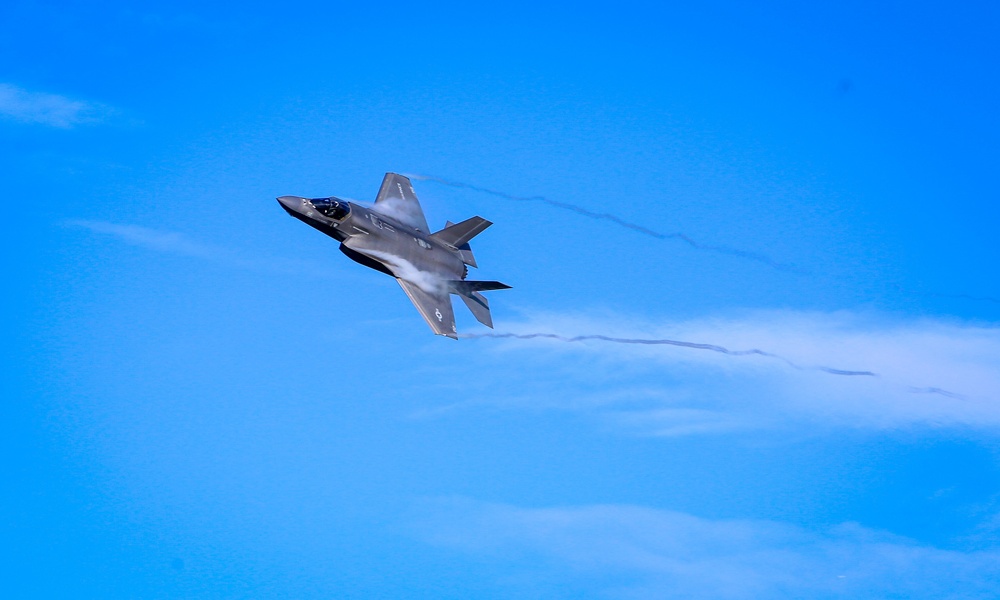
[278,173,510,339]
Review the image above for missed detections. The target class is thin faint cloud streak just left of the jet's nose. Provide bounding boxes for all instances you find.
[64,219,348,277]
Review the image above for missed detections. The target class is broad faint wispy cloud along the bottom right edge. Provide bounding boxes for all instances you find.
[418,499,1000,598]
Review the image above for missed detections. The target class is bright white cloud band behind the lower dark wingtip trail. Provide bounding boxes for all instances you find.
[456,310,1000,435]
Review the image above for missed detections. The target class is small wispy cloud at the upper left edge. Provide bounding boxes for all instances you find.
[0,83,114,128]
